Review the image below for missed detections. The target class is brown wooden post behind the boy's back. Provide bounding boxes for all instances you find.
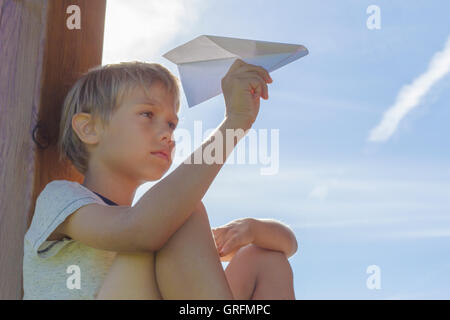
[0,0,106,299]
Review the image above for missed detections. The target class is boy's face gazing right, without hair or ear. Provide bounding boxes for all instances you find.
[95,82,178,183]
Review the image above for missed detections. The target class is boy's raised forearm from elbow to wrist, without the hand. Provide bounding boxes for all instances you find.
[128,118,244,250]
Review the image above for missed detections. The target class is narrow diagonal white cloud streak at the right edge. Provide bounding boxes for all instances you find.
[368,37,450,142]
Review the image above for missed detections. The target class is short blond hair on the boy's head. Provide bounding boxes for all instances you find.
[57,61,180,174]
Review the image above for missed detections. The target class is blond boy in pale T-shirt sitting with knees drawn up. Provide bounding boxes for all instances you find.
[23,59,297,300]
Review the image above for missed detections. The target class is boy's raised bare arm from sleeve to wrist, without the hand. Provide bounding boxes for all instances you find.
[55,119,243,252]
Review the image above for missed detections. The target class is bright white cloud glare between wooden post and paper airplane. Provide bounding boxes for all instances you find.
[102,0,206,64]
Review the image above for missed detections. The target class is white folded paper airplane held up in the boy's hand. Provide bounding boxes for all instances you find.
[163,35,308,108]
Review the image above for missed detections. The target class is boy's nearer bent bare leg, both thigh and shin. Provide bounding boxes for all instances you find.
[96,200,233,300]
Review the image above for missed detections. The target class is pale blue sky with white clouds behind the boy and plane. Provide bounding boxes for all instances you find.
[103,0,450,300]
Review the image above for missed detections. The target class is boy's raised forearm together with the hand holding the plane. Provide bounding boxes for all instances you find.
[132,59,272,250]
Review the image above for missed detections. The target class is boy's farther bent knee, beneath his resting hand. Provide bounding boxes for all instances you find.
[225,244,295,300]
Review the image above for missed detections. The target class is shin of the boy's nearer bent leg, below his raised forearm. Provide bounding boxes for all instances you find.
[155,202,233,300]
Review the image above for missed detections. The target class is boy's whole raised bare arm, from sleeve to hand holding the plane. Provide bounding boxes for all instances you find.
[57,59,271,251]
